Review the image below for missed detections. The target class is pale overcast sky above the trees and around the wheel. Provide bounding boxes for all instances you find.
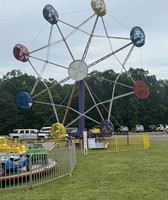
[0,0,168,80]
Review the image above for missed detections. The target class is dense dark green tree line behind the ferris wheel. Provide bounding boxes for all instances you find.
[0,68,168,134]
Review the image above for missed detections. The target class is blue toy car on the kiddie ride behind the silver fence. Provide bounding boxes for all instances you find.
[0,153,29,176]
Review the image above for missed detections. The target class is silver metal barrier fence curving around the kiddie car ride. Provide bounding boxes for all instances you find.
[0,142,76,190]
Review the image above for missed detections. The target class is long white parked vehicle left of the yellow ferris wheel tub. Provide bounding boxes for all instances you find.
[9,129,50,140]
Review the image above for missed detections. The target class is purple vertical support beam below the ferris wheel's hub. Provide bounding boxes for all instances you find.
[78,80,85,136]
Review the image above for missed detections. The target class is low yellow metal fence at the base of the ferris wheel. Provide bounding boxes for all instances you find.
[72,133,150,154]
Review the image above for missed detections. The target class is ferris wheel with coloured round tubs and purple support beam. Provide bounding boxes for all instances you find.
[13,0,149,138]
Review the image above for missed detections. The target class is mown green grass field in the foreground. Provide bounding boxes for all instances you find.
[0,142,168,200]
